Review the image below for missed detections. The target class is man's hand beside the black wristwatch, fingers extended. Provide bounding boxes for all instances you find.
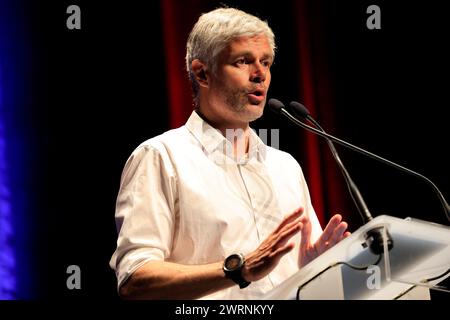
[242,208,303,282]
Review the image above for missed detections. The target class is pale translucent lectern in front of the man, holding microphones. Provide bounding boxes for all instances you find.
[263,215,450,300]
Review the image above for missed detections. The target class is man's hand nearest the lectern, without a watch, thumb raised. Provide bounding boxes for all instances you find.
[298,214,350,268]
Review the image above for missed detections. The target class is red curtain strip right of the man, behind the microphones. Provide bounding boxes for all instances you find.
[294,0,349,225]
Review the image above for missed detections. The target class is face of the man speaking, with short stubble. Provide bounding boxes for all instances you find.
[209,35,273,123]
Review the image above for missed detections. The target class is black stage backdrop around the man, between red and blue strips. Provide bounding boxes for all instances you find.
[7,0,450,299]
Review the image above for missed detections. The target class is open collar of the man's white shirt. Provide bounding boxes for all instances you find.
[185,110,266,162]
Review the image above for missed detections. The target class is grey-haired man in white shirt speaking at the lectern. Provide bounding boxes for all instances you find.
[110,8,349,299]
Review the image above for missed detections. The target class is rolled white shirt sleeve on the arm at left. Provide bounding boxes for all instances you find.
[110,145,176,288]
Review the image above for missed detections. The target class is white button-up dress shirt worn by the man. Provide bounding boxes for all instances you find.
[110,111,322,299]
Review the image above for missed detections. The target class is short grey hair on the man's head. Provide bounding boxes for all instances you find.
[186,8,276,106]
